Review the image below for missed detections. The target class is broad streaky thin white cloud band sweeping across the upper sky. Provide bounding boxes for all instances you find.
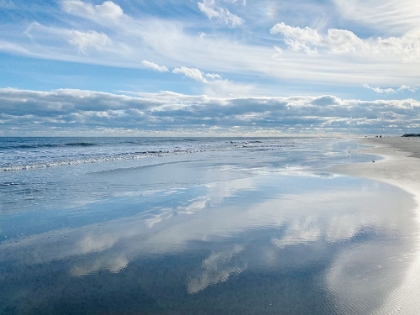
[0,6,420,89]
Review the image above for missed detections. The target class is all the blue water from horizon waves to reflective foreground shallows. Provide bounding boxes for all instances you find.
[0,138,415,314]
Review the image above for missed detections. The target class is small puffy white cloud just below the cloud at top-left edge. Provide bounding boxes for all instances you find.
[68,31,112,53]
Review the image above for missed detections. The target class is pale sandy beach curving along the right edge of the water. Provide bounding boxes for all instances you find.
[332,137,420,314]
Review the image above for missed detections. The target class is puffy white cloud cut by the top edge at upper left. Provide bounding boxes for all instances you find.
[62,0,124,20]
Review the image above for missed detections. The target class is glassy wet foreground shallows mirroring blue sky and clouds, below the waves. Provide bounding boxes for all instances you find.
[0,165,414,314]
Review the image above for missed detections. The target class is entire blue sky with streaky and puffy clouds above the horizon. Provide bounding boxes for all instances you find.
[0,0,420,136]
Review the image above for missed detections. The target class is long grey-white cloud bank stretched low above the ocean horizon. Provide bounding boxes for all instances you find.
[0,89,420,135]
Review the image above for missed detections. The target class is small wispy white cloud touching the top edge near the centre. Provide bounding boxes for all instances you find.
[198,0,246,27]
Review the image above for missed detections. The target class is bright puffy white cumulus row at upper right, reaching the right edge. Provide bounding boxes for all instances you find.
[270,22,420,63]
